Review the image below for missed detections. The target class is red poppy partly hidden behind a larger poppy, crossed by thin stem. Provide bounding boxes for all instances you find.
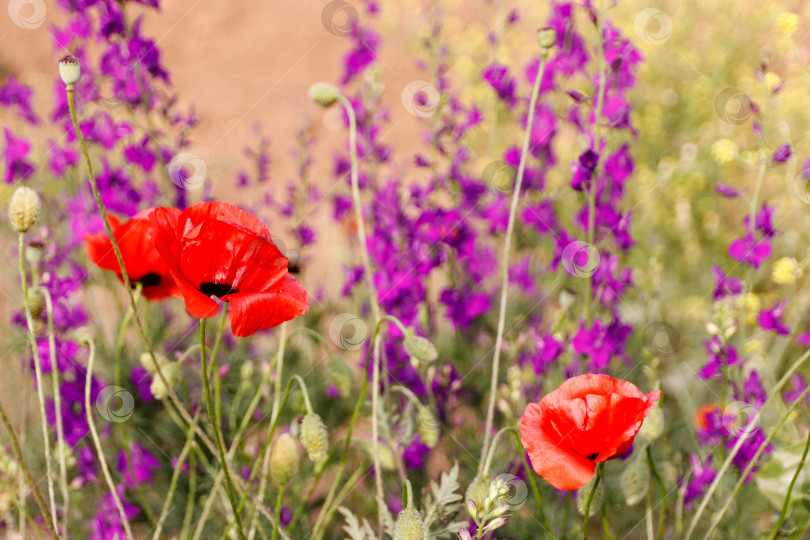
[84,210,180,300]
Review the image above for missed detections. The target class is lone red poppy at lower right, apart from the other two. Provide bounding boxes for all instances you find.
[520,375,661,489]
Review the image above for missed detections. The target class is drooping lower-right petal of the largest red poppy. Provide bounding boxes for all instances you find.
[225,274,309,337]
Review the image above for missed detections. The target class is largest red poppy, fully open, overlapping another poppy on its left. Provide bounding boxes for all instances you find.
[149,202,309,337]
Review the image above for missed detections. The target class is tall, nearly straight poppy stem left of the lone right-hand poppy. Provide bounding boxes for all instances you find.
[478,44,549,475]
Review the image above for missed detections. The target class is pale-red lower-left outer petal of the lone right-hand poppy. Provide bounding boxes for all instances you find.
[520,403,596,490]
